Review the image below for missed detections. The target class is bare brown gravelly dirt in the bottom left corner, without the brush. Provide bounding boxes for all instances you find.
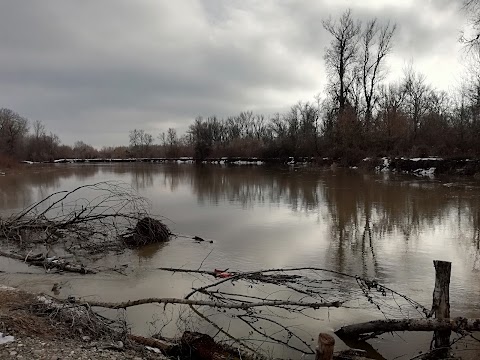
[0,286,166,360]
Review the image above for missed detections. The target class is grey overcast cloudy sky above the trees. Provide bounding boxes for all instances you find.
[0,0,472,147]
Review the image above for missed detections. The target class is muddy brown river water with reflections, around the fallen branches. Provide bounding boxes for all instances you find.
[0,164,480,359]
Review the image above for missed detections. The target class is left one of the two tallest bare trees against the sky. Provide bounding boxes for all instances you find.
[322,10,361,112]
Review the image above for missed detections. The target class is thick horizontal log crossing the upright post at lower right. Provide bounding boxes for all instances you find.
[335,317,480,338]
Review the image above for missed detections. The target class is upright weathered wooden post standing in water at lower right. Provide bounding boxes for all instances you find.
[432,260,452,348]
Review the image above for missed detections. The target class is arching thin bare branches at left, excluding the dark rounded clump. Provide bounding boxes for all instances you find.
[0,181,166,257]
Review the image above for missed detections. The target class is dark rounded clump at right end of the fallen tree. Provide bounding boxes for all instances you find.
[125,217,172,246]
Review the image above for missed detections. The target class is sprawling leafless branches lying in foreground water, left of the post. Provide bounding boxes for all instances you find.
[66,267,426,357]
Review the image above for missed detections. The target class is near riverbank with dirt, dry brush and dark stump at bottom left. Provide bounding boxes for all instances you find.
[0,285,270,360]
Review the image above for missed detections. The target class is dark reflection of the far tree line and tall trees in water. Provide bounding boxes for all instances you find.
[159,166,480,276]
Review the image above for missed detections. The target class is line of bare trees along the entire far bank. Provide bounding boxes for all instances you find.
[0,7,480,163]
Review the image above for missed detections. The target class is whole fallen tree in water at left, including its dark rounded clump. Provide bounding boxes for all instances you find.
[0,181,172,274]
